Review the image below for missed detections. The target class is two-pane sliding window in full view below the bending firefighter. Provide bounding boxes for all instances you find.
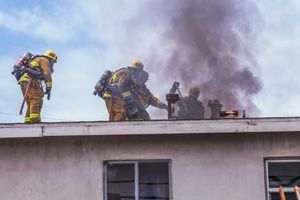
[104,160,171,200]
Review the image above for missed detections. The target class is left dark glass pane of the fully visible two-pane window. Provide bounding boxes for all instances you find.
[107,163,135,200]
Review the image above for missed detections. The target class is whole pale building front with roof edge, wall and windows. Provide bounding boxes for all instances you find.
[0,118,300,200]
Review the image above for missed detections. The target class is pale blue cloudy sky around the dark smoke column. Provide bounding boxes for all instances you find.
[0,0,300,123]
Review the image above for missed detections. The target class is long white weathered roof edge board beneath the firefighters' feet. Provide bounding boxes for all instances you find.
[0,117,300,138]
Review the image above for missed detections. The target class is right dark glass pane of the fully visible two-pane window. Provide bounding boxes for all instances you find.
[139,162,169,200]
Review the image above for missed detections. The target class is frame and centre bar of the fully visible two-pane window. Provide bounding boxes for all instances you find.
[103,159,173,200]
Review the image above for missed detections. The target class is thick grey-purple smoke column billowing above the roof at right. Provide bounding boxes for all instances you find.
[145,0,262,114]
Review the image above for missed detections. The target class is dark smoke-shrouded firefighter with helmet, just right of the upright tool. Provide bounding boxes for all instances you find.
[178,86,204,119]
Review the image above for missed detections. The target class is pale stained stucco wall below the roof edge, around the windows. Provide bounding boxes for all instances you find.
[0,118,300,200]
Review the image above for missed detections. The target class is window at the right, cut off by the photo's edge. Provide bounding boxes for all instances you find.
[266,159,300,200]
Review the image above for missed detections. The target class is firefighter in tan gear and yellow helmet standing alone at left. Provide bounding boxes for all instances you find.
[19,50,57,124]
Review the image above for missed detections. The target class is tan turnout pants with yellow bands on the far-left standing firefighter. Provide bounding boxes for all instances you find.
[20,80,44,124]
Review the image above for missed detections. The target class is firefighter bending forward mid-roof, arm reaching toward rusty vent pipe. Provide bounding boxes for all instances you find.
[103,60,167,121]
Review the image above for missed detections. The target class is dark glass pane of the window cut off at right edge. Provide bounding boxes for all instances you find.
[268,162,300,188]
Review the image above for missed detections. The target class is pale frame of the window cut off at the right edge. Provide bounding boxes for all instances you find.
[264,156,300,200]
